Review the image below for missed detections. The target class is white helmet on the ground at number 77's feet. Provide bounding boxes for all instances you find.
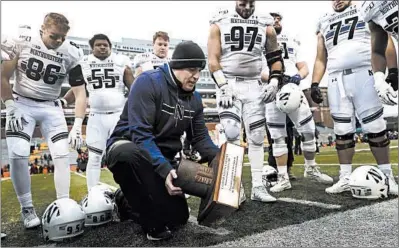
[349,165,389,200]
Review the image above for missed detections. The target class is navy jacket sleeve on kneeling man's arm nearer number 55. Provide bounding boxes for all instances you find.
[128,75,173,178]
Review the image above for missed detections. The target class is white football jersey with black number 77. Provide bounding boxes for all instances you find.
[316,5,371,73]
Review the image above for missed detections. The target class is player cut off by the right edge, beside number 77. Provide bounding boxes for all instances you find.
[360,0,398,95]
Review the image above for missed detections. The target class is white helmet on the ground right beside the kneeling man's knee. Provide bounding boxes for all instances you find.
[81,186,114,226]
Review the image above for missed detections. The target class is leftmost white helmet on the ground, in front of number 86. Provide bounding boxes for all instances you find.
[42,198,85,241]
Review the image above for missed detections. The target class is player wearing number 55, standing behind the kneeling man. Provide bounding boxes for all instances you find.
[64,34,134,191]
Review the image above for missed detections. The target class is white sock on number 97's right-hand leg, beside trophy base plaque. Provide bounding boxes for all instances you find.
[248,144,264,188]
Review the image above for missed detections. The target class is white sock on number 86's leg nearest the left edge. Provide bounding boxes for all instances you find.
[10,158,33,208]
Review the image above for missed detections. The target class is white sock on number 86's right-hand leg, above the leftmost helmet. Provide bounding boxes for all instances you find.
[53,157,71,199]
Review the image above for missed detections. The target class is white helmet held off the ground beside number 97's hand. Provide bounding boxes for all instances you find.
[276,83,303,114]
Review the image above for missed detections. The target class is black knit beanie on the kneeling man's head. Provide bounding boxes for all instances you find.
[169,41,206,69]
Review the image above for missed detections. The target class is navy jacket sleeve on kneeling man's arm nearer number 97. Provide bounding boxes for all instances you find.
[186,96,219,163]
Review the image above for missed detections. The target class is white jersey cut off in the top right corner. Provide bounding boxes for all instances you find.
[360,0,398,40]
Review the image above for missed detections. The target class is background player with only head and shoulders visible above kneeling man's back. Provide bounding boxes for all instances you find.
[133,31,169,78]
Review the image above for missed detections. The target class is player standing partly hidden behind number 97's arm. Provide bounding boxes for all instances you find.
[266,13,333,192]
